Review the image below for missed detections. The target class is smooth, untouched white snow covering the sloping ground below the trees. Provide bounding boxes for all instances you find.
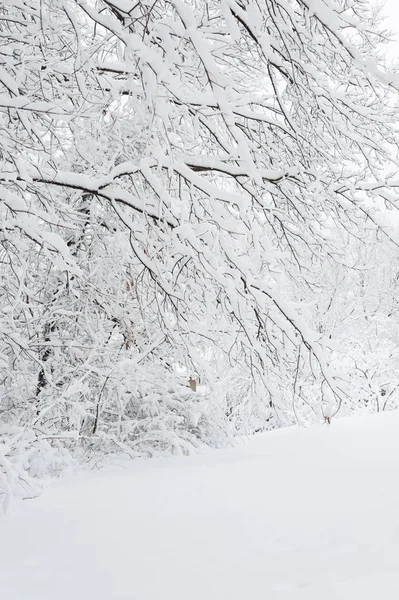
[0,413,399,600]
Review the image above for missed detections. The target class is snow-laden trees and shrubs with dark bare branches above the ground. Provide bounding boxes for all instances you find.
[0,0,399,507]
